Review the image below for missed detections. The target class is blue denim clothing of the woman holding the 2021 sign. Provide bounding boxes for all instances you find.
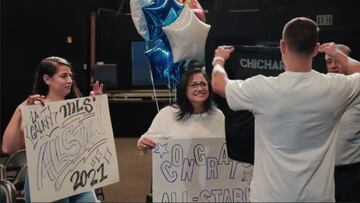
[24,177,100,203]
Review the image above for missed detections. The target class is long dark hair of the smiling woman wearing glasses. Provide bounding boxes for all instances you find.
[172,61,214,121]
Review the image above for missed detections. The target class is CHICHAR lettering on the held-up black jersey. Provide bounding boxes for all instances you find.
[240,58,284,71]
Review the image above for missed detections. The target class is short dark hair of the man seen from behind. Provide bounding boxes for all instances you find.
[282,17,319,55]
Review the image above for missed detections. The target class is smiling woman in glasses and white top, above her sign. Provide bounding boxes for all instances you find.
[137,62,225,151]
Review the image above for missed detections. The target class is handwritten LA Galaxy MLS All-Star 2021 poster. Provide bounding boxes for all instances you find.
[21,95,119,202]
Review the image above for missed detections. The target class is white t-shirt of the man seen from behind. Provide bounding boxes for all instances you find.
[225,70,360,202]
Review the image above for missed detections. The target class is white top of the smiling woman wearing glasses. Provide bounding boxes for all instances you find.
[142,106,225,139]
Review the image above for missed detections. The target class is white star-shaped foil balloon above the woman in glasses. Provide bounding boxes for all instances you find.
[162,5,211,63]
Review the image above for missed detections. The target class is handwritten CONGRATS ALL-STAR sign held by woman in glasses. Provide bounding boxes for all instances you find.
[152,138,253,202]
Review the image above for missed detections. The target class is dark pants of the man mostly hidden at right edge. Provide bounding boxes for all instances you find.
[335,163,360,202]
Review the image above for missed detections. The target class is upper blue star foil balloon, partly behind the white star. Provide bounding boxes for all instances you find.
[142,0,184,40]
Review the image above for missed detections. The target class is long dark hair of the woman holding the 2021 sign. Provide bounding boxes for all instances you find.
[32,56,82,99]
